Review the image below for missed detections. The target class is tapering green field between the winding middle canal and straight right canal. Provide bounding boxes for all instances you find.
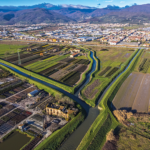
[81,47,134,106]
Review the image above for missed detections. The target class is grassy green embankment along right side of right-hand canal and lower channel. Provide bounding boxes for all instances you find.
[77,50,142,150]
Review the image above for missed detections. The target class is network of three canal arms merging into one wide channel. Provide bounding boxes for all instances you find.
[0,48,141,150]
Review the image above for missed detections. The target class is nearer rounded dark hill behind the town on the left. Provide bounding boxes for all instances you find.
[0,8,75,24]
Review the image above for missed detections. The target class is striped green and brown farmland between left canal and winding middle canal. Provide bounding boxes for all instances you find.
[3,44,90,86]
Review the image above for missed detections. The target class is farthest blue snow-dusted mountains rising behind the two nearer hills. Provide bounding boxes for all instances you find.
[0,3,129,21]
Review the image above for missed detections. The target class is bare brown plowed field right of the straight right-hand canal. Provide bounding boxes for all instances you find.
[113,73,150,112]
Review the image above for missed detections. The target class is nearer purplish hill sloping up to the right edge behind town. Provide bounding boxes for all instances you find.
[83,4,150,24]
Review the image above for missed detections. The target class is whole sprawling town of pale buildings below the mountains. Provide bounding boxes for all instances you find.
[0,23,150,47]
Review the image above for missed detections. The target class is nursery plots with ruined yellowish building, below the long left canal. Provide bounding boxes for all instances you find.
[0,66,79,150]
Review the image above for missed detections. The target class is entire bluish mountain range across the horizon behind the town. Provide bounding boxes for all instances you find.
[0,3,150,24]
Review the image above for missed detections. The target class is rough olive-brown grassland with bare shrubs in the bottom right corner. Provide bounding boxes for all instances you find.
[114,111,150,150]
